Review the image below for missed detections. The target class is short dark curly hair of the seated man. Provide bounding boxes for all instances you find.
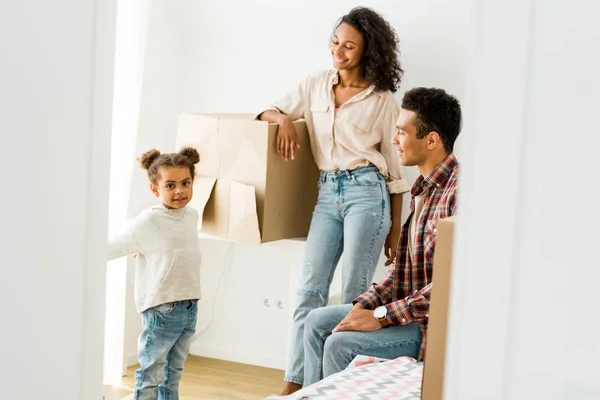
[402,87,462,153]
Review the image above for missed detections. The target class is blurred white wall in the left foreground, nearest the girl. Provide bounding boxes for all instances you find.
[0,0,115,400]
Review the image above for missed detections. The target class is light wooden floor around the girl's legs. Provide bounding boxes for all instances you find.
[104,356,284,400]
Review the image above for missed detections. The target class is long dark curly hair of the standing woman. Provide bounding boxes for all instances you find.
[334,7,404,93]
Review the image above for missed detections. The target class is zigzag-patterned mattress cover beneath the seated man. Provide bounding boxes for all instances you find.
[267,356,423,400]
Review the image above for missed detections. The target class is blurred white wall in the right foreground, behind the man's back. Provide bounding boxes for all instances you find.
[444,0,600,400]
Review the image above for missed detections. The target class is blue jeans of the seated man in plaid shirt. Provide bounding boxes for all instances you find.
[304,304,422,387]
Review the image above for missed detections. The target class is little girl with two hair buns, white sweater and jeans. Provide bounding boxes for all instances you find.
[109,147,200,400]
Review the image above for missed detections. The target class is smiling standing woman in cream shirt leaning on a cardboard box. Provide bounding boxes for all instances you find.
[258,7,408,394]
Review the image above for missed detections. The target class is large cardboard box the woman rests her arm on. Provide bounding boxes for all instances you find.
[176,113,319,244]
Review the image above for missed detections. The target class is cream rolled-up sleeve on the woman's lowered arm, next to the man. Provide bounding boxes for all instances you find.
[380,96,410,194]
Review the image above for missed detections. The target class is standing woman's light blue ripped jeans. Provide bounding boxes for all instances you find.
[285,165,392,384]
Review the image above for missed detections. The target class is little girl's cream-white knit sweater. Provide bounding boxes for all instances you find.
[108,206,200,313]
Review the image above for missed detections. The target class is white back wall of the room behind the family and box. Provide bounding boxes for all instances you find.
[115,0,470,368]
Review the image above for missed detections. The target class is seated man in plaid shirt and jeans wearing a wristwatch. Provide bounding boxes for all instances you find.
[304,88,461,386]
